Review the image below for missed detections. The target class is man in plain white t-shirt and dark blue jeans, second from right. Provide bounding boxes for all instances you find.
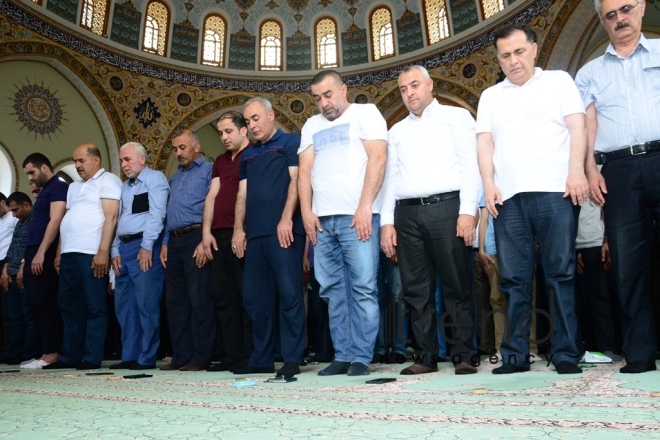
[477,24,589,374]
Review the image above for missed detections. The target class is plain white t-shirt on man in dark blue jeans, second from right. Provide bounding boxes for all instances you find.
[477,67,584,200]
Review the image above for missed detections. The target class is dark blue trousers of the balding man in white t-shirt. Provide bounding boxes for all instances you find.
[58,252,108,366]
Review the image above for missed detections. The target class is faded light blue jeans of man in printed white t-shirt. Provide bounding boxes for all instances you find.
[314,214,380,365]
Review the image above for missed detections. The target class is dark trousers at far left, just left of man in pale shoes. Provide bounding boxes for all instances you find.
[4,276,40,359]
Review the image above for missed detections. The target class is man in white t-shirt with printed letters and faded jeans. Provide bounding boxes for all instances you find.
[298,70,387,376]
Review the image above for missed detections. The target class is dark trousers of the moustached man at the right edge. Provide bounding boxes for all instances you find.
[602,153,660,362]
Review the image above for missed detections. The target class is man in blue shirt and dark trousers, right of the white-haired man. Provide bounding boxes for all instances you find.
[160,130,215,371]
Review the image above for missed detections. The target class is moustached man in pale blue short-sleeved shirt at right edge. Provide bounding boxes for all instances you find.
[575,0,660,373]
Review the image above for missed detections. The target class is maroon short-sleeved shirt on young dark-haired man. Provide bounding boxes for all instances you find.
[211,150,244,229]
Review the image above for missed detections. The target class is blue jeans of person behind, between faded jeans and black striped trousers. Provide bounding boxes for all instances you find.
[375,252,410,355]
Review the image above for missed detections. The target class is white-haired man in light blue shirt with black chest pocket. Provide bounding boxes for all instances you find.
[110,142,170,370]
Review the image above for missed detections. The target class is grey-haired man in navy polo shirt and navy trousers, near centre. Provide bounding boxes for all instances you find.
[231,98,305,377]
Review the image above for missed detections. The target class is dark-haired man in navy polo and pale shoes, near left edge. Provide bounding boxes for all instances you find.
[18,153,69,369]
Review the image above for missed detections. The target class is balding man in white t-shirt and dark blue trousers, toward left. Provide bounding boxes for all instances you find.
[44,144,121,370]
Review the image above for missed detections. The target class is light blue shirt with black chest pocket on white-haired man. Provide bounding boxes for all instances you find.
[110,168,170,258]
